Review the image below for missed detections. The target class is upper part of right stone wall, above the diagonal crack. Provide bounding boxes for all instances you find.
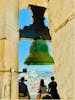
[48,0,74,33]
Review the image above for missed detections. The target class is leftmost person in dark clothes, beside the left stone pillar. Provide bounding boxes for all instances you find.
[19,77,30,99]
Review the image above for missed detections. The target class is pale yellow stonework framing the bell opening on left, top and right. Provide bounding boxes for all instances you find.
[0,0,75,99]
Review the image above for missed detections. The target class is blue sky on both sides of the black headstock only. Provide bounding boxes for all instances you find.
[19,9,49,29]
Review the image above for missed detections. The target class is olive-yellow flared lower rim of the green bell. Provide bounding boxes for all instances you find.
[24,56,54,65]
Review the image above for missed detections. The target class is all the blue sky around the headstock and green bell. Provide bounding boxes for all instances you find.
[18,9,52,71]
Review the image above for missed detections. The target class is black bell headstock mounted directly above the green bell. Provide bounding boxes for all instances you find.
[20,5,51,40]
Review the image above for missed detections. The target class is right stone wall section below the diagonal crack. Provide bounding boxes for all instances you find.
[52,20,75,100]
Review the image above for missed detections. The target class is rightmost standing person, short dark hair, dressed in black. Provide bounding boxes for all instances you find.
[48,76,60,99]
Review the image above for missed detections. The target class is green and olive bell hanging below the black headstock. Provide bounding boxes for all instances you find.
[24,39,54,65]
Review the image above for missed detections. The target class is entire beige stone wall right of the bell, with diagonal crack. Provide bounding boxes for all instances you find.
[48,0,75,100]
